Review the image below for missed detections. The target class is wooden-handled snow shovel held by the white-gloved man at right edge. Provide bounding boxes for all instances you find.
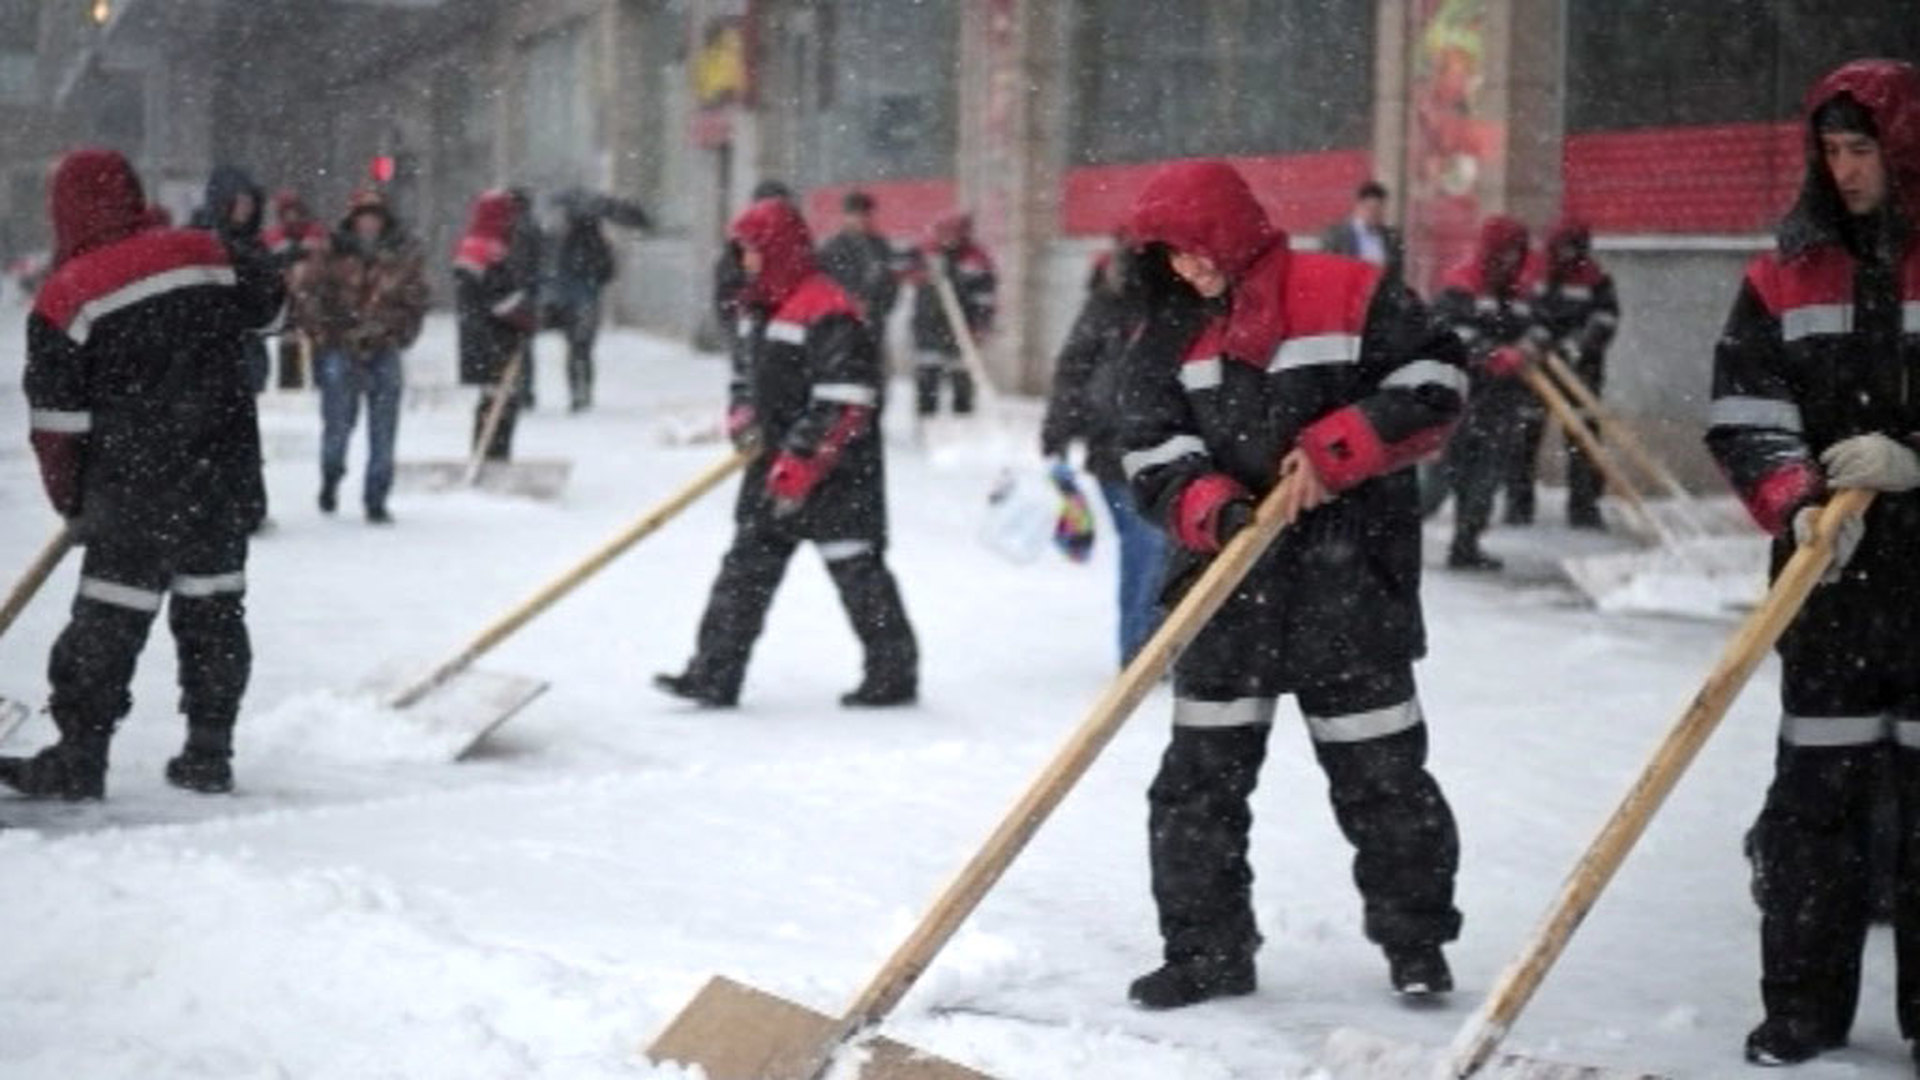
[1327,490,1874,1080]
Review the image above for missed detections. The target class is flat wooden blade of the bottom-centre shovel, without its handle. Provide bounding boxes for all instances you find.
[647,976,993,1080]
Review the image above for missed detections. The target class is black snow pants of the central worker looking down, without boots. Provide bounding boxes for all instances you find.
[1148,665,1461,963]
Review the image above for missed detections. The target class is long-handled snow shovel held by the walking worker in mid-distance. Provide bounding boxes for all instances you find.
[388,450,753,759]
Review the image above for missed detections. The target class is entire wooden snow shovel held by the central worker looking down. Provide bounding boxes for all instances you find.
[647,476,1286,1080]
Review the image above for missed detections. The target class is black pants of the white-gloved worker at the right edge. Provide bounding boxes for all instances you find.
[1753,568,1920,1040]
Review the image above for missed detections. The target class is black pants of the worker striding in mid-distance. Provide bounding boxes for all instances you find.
[687,519,920,694]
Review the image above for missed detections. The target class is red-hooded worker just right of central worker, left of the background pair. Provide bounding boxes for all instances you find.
[1434,215,1540,571]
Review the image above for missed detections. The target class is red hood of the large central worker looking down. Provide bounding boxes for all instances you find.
[1127,160,1286,279]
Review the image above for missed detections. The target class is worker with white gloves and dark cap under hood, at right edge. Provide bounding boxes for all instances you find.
[1707,60,1920,1065]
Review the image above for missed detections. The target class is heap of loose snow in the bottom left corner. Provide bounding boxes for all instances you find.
[0,836,672,1080]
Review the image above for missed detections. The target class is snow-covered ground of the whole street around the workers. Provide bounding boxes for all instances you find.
[0,311,1910,1080]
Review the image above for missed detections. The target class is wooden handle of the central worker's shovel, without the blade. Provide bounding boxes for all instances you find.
[847,472,1283,1032]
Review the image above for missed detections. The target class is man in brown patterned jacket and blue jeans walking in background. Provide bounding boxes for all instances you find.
[294,192,428,525]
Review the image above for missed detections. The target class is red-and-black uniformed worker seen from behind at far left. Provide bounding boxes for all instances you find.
[0,150,284,799]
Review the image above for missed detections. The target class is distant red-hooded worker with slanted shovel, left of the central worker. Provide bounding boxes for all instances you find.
[912,211,998,417]
